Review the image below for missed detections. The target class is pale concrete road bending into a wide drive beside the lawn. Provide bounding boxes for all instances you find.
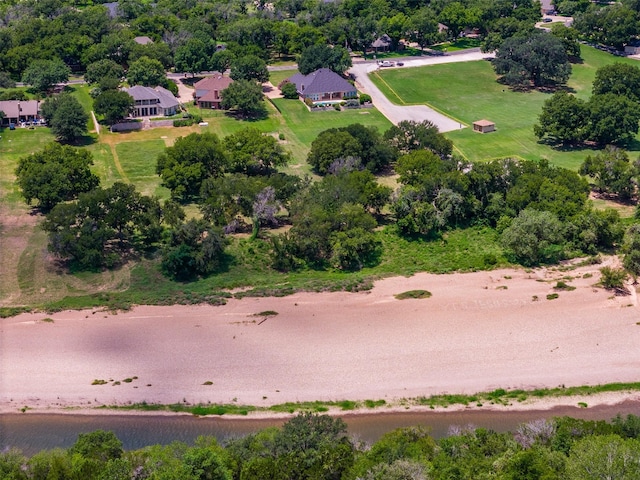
[349,51,493,132]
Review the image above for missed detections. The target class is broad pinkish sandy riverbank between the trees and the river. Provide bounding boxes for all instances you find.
[0,265,640,413]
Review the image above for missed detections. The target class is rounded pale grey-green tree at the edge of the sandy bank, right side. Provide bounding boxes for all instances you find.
[501,209,564,266]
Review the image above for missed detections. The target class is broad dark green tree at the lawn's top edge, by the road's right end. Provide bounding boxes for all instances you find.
[493,32,571,88]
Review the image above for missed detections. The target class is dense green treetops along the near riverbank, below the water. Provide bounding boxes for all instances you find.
[0,413,640,480]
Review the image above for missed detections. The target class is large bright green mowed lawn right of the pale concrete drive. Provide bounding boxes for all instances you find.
[372,46,640,169]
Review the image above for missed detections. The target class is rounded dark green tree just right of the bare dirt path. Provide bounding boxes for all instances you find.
[156,133,227,201]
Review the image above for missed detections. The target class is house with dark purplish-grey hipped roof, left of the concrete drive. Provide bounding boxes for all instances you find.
[287,68,358,103]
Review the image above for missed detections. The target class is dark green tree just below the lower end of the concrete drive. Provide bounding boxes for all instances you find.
[384,120,453,158]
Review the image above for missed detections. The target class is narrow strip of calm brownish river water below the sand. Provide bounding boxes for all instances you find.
[0,401,640,455]
